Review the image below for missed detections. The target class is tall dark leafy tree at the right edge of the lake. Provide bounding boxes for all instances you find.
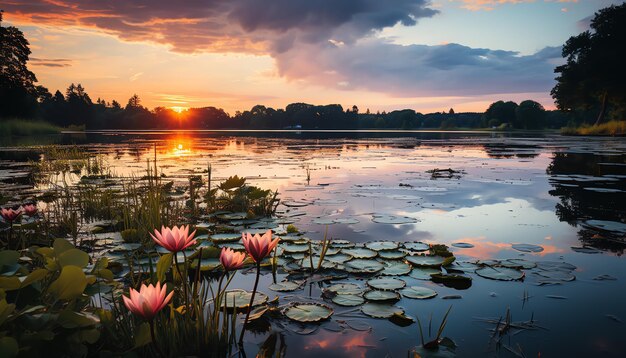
[551,3,626,124]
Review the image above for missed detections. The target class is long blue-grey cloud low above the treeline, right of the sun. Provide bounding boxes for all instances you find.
[276,39,561,97]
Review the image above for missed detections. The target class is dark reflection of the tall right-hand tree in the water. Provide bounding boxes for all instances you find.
[546,152,626,253]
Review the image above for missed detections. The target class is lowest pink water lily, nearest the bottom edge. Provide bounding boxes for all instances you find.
[122,282,174,321]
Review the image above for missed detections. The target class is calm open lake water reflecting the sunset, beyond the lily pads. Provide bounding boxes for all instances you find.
[0,132,626,357]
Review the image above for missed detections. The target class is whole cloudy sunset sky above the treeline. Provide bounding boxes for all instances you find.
[0,0,623,114]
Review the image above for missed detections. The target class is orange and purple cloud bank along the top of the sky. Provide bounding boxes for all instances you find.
[3,0,437,53]
